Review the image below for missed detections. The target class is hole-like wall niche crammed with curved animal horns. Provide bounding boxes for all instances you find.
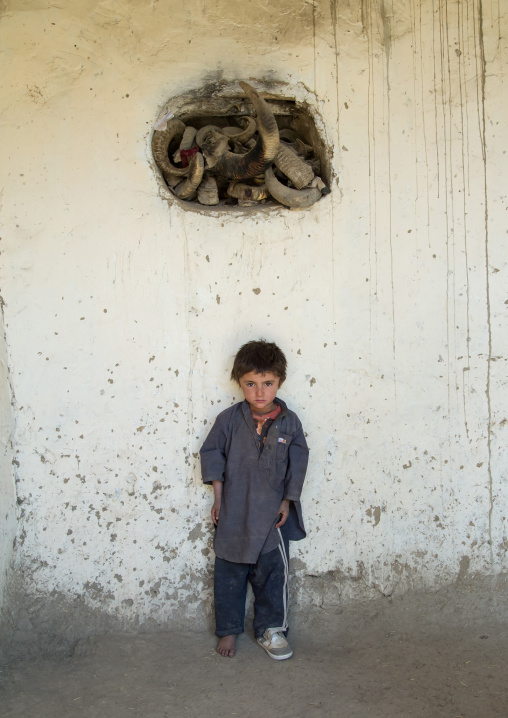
[151,81,332,213]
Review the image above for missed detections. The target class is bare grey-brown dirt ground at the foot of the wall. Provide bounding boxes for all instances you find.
[0,591,508,718]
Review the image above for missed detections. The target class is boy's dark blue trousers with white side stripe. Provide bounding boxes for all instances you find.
[214,531,289,638]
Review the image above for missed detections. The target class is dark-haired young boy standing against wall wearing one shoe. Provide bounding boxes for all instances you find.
[200,340,309,661]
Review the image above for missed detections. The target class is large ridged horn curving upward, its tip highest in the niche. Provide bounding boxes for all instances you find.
[216,82,279,179]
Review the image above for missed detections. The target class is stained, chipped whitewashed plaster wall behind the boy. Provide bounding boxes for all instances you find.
[0,0,508,622]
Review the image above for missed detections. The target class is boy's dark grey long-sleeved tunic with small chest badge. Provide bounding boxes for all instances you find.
[200,398,309,563]
